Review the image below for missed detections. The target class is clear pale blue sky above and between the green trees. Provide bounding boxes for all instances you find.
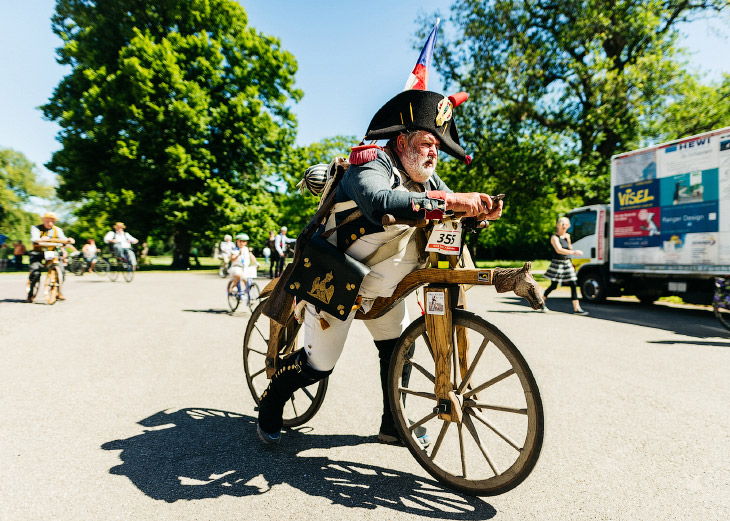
[0,0,730,187]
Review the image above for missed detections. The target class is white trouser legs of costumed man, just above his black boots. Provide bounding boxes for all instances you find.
[302,299,411,371]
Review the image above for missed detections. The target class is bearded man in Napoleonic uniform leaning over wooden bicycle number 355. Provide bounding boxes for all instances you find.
[257,90,502,443]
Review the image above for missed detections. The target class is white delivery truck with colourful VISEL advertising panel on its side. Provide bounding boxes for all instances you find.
[568,127,730,304]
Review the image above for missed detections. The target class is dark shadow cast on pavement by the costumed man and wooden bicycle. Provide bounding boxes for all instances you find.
[102,408,496,519]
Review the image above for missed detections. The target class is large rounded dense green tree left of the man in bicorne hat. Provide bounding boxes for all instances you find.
[42,0,301,267]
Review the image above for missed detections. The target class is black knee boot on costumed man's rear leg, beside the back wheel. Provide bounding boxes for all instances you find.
[258,349,332,443]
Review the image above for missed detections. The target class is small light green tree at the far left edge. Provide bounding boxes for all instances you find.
[0,148,53,243]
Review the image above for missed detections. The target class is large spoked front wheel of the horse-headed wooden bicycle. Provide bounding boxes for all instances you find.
[389,310,544,495]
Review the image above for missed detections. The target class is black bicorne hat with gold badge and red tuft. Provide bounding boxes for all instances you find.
[365,90,471,162]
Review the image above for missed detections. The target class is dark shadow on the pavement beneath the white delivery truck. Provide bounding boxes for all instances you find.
[489,297,730,347]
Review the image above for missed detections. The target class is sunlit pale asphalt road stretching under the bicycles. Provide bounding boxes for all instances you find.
[0,272,730,521]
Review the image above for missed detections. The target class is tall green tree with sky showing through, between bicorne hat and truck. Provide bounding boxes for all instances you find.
[423,0,730,254]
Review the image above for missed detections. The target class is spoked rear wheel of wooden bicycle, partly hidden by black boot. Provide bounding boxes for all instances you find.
[243,302,329,427]
